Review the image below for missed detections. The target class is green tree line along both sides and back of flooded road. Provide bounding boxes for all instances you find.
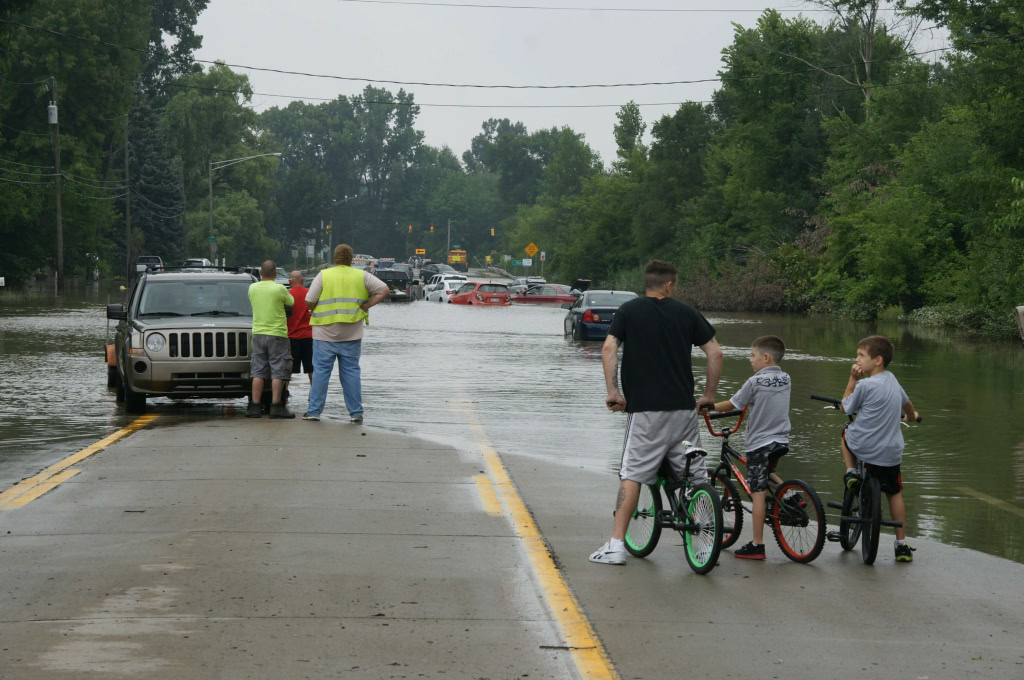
[0,0,1024,334]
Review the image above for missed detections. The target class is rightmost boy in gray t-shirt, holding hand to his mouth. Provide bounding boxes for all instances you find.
[843,335,918,562]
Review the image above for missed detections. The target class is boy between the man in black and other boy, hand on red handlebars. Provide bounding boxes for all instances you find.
[715,335,792,559]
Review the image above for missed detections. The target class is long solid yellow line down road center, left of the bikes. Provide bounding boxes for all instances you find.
[454,403,618,680]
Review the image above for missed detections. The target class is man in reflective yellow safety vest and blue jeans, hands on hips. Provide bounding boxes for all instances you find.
[302,244,389,425]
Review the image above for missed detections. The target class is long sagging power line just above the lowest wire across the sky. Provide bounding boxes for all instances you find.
[0,18,999,90]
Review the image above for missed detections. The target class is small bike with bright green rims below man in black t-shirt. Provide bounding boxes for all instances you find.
[626,441,722,573]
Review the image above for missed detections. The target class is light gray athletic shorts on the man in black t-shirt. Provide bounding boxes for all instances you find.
[618,411,708,484]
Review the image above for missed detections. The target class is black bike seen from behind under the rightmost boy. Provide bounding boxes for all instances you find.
[811,394,921,564]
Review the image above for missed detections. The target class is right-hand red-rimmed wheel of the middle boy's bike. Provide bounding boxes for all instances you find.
[769,479,826,564]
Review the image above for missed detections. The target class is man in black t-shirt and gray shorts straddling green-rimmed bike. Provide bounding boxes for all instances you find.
[590,260,722,564]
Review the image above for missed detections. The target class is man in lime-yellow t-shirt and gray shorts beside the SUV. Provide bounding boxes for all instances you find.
[246,260,295,418]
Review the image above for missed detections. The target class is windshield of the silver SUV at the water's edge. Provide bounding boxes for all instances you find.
[138,281,253,316]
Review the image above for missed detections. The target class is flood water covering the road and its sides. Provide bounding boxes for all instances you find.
[0,280,1024,562]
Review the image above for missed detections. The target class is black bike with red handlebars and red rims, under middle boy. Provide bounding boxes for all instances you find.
[705,409,827,564]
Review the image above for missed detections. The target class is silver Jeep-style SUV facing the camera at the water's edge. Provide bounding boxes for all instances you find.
[106,270,260,413]
